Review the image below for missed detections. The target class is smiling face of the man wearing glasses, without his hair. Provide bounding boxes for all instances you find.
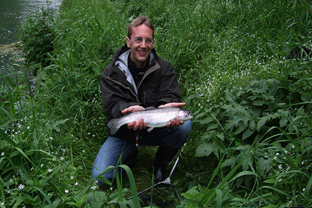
[126,24,154,68]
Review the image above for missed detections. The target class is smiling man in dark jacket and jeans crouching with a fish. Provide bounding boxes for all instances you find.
[92,16,192,187]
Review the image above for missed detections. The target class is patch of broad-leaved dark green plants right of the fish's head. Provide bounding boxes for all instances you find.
[196,72,312,182]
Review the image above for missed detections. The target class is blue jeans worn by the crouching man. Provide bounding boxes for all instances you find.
[92,120,192,187]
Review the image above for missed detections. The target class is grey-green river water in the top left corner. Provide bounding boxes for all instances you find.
[0,0,62,45]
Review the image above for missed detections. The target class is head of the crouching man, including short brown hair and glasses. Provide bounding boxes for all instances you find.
[126,16,155,68]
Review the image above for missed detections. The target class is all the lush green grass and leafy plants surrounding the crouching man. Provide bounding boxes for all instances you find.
[0,0,312,207]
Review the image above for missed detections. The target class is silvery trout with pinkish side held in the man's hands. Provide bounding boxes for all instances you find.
[107,107,193,135]
